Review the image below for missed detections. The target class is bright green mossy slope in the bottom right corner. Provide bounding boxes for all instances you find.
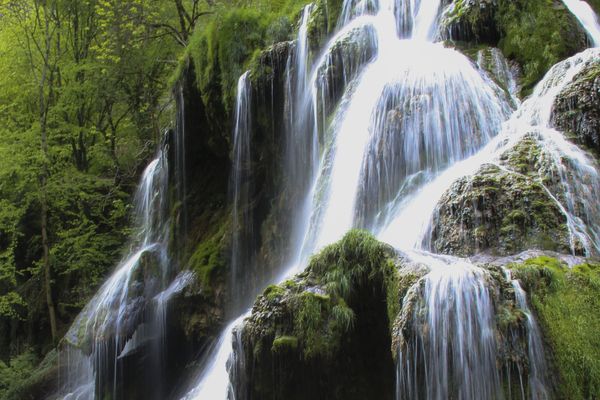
[513,257,600,400]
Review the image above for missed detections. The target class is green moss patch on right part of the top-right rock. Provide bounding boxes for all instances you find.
[497,0,585,94]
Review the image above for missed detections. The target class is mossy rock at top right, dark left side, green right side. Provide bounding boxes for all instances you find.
[442,0,588,95]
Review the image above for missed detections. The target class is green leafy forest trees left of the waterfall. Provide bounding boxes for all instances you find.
[0,0,229,376]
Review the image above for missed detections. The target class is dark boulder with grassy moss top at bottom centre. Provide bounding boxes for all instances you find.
[234,231,402,399]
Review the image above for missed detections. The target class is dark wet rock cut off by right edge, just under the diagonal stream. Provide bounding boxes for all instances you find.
[552,62,600,156]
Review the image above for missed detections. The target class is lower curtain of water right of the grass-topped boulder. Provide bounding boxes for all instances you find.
[396,257,502,400]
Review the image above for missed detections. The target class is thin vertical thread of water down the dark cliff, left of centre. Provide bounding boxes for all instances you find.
[229,71,254,310]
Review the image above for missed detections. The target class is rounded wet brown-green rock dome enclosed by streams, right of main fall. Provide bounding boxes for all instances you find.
[431,165,569,256]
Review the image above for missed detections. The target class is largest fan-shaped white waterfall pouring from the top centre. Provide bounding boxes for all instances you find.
[304,1,510,254]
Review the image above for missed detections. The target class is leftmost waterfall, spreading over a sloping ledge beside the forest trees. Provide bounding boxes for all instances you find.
[61,151,172,399]
